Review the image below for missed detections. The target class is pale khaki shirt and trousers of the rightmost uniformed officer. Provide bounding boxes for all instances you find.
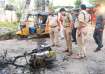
[77,10,89,56]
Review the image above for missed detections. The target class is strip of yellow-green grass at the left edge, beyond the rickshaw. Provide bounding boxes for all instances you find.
[0,21,18,31]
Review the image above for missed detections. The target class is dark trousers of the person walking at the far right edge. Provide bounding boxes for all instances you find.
[93,30,103,49]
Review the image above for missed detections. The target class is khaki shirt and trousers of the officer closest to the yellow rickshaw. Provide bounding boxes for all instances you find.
[47,16,59,45]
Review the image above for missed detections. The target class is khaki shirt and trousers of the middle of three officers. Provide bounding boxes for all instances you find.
[63,14,72,52]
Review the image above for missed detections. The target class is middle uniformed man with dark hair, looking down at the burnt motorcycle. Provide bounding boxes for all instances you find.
[60,8,72,56]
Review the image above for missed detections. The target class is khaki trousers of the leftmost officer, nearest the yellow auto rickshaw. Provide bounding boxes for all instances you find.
[49,27,59,45]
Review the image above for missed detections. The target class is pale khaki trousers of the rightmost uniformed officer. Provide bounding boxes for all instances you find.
[77,27,87,56]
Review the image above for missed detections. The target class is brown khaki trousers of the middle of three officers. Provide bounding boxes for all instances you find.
[64,27,72,52]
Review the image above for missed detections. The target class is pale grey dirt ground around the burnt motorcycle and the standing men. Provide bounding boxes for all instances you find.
[0,27,105,74]
